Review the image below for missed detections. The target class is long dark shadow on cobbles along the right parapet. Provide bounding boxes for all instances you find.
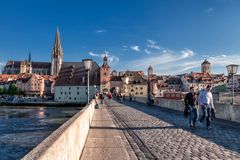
[113,101,240,153]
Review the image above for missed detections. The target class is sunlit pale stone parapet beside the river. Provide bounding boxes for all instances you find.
[22,100,95,160]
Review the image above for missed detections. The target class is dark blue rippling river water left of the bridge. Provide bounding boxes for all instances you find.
[0,106,80,160]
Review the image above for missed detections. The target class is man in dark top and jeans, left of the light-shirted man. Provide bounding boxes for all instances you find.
[184,87,198,128]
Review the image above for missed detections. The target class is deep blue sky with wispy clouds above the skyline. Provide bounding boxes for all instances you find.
[0,0,240,74]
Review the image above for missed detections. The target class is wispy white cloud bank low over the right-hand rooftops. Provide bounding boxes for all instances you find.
[126,44,240,74]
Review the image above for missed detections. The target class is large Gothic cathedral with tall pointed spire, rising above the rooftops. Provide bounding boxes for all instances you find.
[2,29,63,76]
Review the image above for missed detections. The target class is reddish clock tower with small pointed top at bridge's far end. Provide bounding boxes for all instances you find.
[100,55,110,93]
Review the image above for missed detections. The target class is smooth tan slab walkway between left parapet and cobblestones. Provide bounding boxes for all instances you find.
[81,105,130,160]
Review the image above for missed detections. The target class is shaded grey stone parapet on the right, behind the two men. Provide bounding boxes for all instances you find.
[154,98,240,122]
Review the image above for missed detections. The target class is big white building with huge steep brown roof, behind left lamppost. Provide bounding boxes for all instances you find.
[54,62,100,103]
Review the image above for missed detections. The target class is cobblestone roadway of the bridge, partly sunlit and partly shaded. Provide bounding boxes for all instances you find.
[107,101,240,160]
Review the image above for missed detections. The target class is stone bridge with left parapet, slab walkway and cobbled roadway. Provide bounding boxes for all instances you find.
[23,100,240,160]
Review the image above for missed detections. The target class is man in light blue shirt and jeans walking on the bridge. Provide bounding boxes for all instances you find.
[198,85,216,129]
